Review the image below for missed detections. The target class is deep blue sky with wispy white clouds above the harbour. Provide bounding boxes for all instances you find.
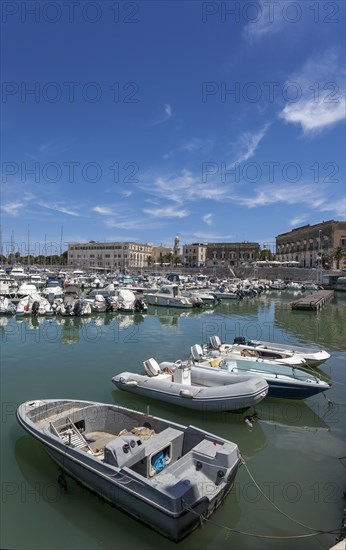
[1,0,345,254]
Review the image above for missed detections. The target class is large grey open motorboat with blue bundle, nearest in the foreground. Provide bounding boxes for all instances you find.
[17,399,242,542]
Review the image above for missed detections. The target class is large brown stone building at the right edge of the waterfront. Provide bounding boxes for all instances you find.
[276,220,346,268]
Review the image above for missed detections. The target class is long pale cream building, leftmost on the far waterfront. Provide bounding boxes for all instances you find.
[67,241,153,271]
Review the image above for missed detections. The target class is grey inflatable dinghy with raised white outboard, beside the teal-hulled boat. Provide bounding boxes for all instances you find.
[112,358,268,411]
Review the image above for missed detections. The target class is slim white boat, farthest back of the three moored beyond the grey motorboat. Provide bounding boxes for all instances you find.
[208,336,330,367]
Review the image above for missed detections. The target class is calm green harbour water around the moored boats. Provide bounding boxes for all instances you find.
[0,291,346,550]
